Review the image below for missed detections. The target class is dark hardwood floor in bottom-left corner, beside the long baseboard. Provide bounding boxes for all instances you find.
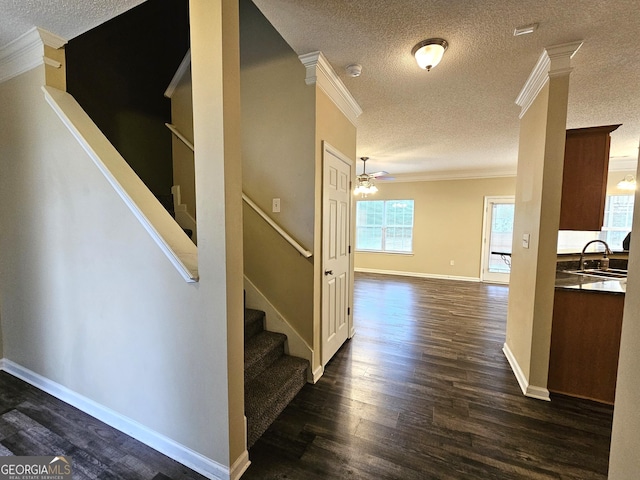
[0,372,205,480]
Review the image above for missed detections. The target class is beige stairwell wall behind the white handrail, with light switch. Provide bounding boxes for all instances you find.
[240,0,315,345]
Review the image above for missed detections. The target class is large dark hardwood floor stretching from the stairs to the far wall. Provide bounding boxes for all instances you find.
[243,274,613,480]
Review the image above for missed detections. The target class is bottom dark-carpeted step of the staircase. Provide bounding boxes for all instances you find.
[244,355,309,447]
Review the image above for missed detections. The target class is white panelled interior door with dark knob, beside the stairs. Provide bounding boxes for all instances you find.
[322,145,351,366]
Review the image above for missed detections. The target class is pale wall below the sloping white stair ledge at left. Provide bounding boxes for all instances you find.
[0,29,242,476]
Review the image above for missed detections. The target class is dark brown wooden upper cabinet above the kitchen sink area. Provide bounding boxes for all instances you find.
[560,125,620,231]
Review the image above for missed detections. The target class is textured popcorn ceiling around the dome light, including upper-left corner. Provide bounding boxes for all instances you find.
[0,0,640,178]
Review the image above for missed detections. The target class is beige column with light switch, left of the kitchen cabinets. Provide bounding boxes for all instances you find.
[506,74,569,396]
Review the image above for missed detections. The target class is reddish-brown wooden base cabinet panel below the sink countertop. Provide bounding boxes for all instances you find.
[547,289,624,404]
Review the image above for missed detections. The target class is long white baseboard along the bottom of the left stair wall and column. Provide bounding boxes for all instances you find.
[0,358,249,480]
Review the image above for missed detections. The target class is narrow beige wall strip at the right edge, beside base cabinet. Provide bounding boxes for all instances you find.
[608,161,640,480]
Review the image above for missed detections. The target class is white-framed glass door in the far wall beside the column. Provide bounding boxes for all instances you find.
[482,196,515,283]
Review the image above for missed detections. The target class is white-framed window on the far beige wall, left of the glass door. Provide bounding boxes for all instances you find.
[356,200,413,253]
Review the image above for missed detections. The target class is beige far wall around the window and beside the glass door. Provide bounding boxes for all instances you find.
[355,177,516,279]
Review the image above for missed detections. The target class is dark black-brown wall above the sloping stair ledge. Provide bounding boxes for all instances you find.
[66,0,189,195]
